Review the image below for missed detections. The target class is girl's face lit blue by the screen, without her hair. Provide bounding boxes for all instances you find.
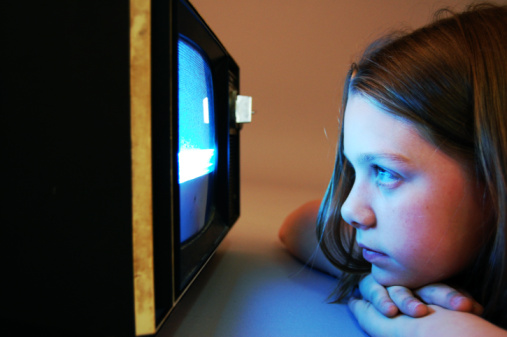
[341,94,485,288]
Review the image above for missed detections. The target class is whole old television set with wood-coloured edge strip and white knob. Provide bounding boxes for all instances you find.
[0,0,251,336]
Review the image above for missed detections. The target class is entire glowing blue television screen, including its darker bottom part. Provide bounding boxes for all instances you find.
[178,37,217,242]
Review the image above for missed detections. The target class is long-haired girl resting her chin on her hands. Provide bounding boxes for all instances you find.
[280,5,507,337]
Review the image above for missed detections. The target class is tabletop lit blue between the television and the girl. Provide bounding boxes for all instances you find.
[159,183,367,337]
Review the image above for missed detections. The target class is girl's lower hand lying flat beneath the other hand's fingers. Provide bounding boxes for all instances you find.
[349,298,507,337]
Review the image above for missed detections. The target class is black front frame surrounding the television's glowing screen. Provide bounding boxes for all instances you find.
[152,0,240,325]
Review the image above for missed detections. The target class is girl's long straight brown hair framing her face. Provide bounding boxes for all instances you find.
[317,4,507,327]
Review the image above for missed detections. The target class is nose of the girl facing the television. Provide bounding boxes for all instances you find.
[341,183,376,229]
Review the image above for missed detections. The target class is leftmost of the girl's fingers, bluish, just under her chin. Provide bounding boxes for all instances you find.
[359,275,398,317]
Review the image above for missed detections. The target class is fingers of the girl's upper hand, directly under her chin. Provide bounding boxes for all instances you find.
[359,274,483,317]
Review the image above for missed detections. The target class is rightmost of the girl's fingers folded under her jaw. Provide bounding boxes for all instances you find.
[415,283,483,315]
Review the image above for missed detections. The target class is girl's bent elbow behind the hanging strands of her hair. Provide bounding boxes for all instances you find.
[278,200,341,276]
